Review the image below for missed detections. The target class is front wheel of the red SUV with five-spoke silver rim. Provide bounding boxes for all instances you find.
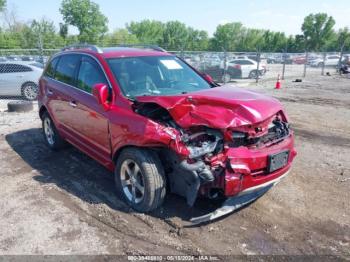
[114,148,166,213]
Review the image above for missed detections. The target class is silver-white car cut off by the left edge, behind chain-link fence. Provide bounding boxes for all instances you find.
[0,61,43,100]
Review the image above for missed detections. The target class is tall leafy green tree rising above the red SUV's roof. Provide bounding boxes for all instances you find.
[60,0,108,43]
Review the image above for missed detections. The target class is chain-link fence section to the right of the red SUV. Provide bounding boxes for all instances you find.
[173,52,350,83]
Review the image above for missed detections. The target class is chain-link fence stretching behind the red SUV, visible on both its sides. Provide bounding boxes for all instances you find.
[0,49,350,104]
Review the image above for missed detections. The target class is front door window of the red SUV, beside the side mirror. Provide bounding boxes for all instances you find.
[77,56,108,93]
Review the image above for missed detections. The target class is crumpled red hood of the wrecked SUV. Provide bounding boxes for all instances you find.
[137,85,282,129]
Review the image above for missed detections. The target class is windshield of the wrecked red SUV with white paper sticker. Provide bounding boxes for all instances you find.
[108,56,211,97]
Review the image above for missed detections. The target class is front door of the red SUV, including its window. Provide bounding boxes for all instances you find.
[64,55,111,165]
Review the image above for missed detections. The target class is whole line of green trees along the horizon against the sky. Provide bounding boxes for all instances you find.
[0,0,350,52]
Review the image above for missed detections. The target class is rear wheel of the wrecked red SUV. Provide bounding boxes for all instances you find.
[42,112,67,151]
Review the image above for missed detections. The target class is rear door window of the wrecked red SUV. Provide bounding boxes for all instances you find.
[55,55,80,85]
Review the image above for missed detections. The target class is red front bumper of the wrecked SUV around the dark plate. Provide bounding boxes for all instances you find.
[220,135,297,197]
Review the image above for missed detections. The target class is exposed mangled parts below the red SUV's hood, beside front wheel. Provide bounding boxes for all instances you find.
[134,102,290,206]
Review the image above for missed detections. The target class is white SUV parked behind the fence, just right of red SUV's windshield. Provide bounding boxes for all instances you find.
[221,58,266,78]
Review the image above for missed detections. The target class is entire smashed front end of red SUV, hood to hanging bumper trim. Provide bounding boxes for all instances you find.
[134,86,296,223]
